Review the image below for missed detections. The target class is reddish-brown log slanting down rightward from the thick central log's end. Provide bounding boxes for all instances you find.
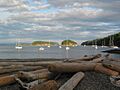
[95,63,119,76]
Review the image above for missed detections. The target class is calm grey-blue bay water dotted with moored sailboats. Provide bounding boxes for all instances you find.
[0,45,120,59]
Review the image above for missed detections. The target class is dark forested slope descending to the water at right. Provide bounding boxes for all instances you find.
[81,32,120,47]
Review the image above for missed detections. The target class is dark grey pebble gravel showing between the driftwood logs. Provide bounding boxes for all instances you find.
[0,72,120,90]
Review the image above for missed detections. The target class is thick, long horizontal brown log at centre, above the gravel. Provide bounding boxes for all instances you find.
[48,63,96,72]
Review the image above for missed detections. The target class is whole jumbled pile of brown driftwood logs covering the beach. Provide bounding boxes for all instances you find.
[0,54,120,90]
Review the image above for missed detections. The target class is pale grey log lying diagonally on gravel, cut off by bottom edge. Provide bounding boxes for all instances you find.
[59,72,84,90]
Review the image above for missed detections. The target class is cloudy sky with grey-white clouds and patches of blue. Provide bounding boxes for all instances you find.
[0,0,120,43]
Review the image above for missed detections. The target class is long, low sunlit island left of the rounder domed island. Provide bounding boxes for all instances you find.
[32,41,58,46]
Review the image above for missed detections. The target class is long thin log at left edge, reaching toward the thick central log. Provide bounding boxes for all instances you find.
[0,66,43,74]
